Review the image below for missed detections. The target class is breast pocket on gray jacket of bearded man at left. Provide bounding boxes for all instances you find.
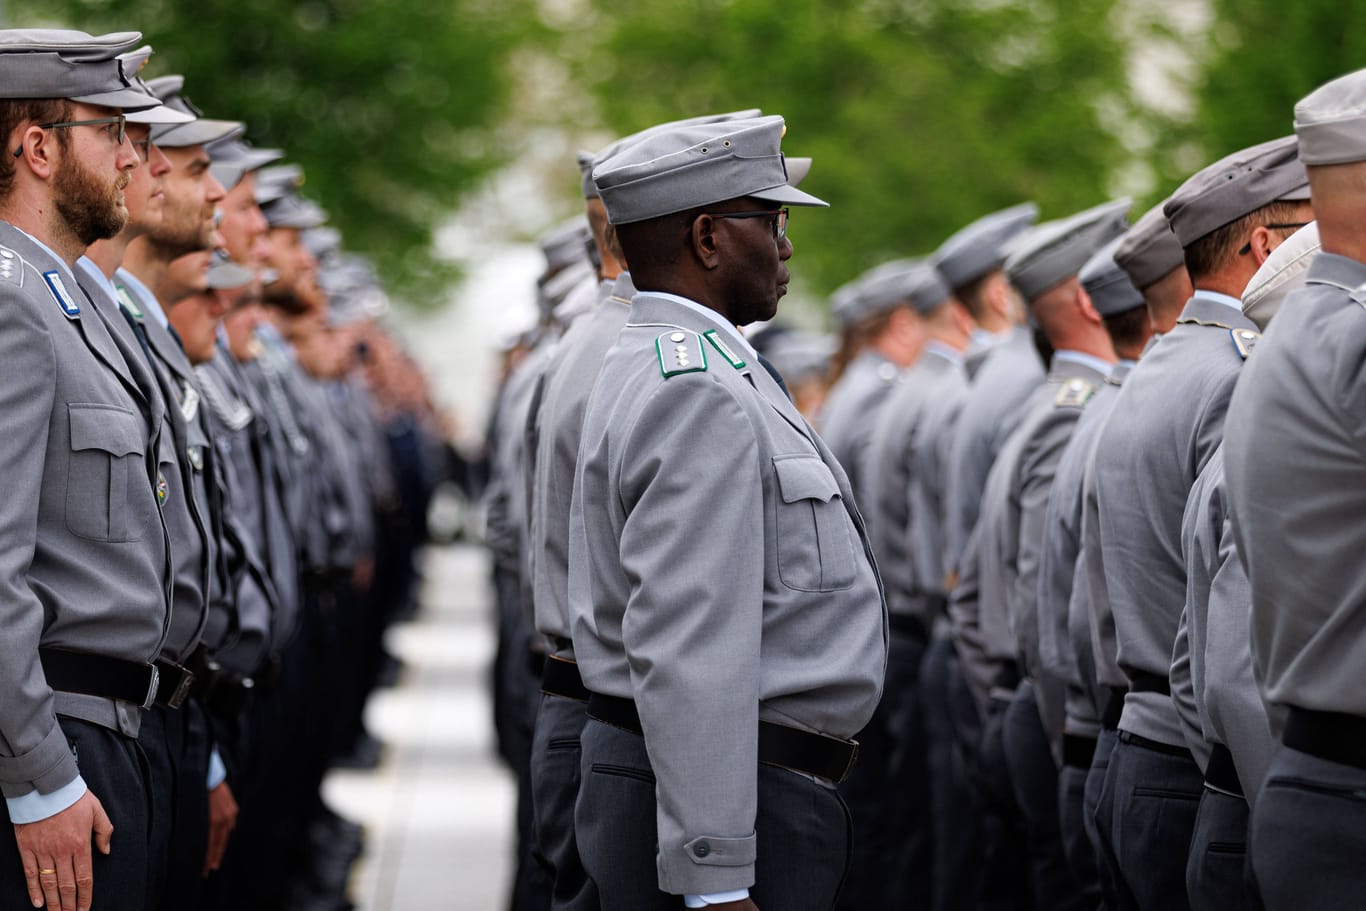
[67,404,149,544]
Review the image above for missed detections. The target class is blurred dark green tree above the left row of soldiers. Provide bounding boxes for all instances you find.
[16,0,534,303]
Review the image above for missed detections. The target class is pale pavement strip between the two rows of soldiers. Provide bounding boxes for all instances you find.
[324,545,515,911]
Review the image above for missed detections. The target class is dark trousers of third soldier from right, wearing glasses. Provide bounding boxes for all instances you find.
[1105,731,1205,911]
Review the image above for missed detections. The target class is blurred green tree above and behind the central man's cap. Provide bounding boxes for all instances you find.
[549,0,1127,305]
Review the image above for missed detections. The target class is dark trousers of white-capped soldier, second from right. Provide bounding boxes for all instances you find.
[1186,784,1261,911]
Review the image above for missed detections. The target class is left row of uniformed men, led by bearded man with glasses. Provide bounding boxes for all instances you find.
[0,29,444,911]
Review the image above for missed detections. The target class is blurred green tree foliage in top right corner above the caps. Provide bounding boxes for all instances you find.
[1154,0,1366,188]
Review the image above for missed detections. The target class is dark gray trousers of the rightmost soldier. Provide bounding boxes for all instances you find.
[1250,746,1366,911]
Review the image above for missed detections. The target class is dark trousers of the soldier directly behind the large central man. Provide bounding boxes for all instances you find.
[531,694,598,911]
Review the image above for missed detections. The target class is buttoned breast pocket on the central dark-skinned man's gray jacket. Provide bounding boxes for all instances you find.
[773,455,856,591]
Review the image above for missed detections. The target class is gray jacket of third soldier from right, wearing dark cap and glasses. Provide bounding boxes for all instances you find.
[1093,292,1257,746]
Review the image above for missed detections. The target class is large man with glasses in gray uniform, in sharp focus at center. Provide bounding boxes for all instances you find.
[570,117,887,911]
